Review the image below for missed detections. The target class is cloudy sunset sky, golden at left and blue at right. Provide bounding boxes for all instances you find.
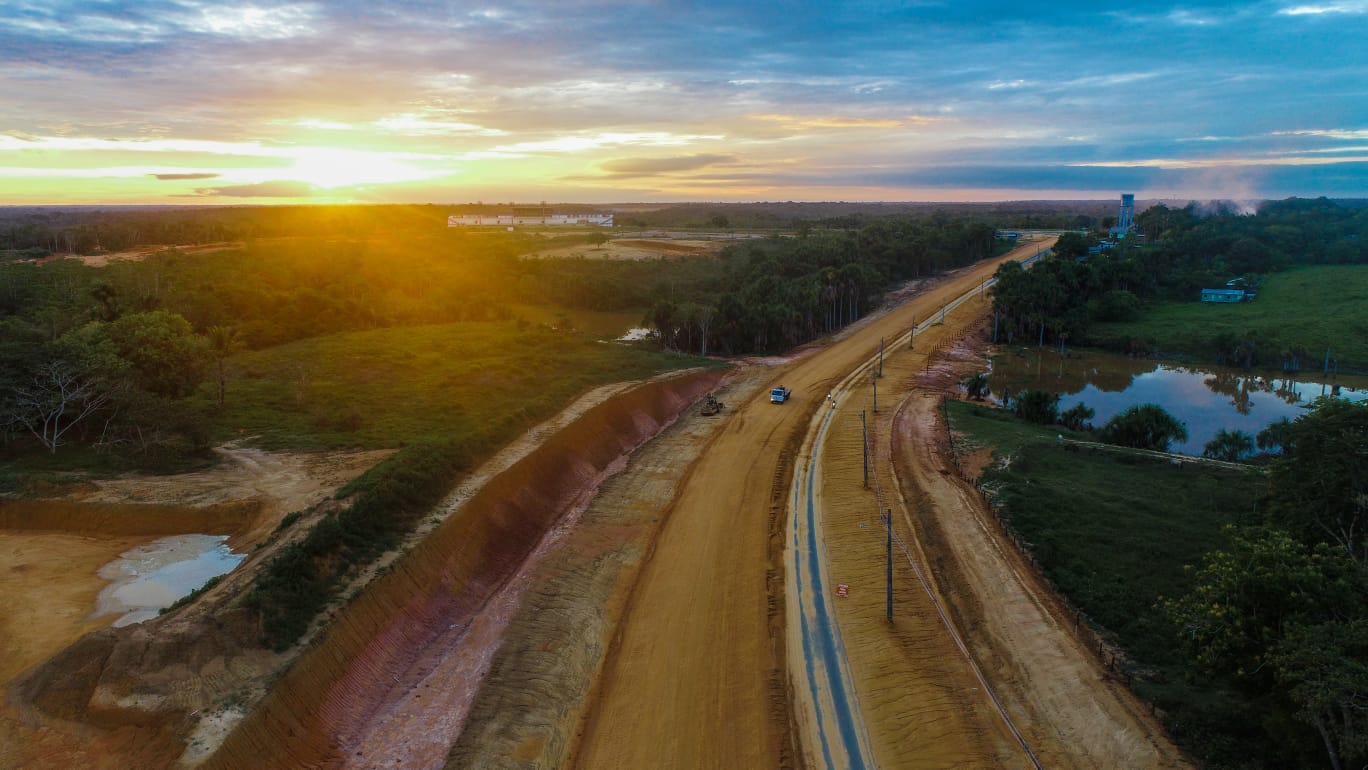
[0,0,1368,205]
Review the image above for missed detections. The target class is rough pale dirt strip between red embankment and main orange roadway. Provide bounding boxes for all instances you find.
[447,371,767,767]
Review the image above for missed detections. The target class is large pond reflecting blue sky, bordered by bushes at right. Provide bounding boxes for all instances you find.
[988,347,1368,455]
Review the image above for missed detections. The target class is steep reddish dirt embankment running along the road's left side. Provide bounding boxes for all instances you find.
[207,371,724,769]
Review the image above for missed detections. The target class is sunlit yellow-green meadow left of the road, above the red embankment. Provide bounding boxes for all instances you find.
[200,321,715,449]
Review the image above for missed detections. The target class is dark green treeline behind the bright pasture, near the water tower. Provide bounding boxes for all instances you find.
[993,198,1368,365]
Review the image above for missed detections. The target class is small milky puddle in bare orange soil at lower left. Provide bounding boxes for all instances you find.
[93,535,246,628]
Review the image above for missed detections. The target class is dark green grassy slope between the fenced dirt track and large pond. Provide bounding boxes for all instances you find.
[947,401,1265,767]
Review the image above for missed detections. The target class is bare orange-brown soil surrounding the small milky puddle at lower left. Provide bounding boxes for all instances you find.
[0,446,390,769]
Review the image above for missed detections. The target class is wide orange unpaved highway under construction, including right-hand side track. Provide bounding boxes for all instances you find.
[573,237,1183,767]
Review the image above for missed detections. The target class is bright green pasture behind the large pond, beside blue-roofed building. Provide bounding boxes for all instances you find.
[1089,265,1368,372]
